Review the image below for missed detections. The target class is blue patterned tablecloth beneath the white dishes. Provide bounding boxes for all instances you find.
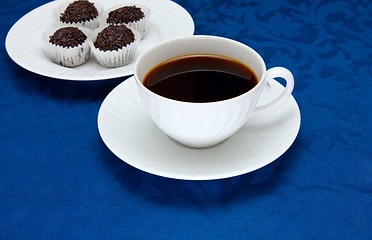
[0,0,372,240]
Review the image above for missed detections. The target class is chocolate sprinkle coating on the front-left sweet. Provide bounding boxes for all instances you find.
[49,27,87,47]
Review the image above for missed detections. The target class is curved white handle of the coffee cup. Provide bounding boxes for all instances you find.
[251,67,294,116]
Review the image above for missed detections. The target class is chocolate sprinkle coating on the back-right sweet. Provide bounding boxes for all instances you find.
[107,6,145,24]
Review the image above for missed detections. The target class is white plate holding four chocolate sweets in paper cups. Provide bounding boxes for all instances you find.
[6,0,194,80]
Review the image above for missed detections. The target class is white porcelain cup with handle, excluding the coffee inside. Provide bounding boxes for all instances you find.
[134,35,294,148]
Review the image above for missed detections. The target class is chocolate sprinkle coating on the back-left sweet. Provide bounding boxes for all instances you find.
[60,0,98,23]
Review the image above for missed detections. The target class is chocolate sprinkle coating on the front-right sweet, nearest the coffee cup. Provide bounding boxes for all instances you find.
[94,25,135,51]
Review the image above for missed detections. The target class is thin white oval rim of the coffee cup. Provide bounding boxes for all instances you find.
[134,35,267,105]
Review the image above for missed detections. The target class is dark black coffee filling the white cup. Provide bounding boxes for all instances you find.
[143,55,258,102]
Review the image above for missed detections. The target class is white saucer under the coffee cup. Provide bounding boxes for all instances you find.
[98,77,300,180]
